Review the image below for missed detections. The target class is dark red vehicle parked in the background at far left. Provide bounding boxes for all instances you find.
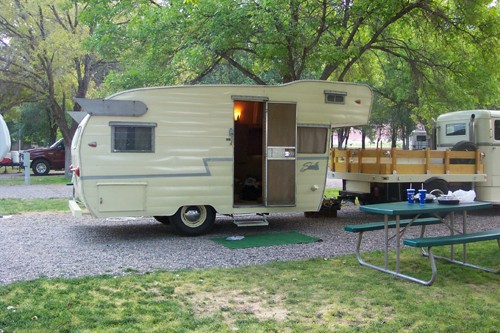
[21,139,65,176]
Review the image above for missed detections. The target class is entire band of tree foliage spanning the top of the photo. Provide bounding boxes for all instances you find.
[0,0,500,148]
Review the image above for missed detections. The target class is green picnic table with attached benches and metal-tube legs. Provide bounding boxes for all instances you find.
[344,201,500,285]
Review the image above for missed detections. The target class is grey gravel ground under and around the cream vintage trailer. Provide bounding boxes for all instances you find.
[0,175,500,284]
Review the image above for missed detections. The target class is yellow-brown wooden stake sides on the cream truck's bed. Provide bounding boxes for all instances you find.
[331,148,484,174]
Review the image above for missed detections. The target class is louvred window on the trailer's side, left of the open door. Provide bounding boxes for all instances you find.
[109,122,156,153]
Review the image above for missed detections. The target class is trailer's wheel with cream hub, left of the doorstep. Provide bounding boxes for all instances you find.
[170,206,215,236]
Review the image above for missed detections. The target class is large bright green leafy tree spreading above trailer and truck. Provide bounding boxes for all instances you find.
[78,0,500,146]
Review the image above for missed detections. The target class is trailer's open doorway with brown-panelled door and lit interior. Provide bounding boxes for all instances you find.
[234,97,297,207]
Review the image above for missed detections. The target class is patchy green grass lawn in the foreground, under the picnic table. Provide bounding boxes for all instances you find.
[0,241,500,333]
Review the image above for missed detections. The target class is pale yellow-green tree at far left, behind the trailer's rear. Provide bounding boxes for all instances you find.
[0,0,103,150]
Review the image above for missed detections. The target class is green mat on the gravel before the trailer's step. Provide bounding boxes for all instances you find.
[212,231,321,249]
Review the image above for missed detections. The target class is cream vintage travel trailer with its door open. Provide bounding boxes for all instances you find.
[70,81,372,235]
